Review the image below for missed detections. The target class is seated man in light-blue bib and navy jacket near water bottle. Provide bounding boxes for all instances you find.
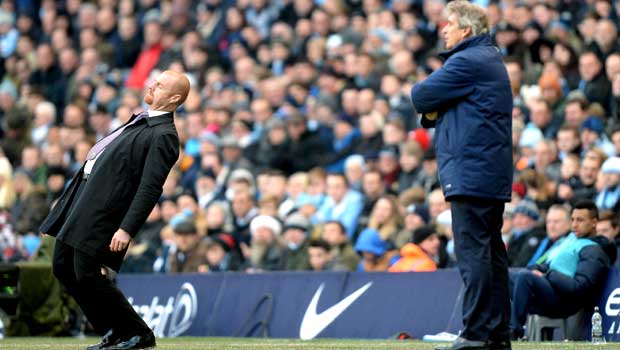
[510,201,615,338]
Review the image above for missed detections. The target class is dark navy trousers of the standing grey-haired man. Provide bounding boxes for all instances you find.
[450,197,510,341]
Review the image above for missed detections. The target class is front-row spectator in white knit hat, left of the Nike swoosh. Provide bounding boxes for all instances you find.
[247,215,286,272]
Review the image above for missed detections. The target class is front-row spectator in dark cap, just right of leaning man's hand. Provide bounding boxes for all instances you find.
[167,219,207,274]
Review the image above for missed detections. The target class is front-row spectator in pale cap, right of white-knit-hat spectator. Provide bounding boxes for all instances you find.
[282,212,310,271]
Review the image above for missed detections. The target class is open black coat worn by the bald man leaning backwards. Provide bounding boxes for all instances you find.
[41,113,179,271]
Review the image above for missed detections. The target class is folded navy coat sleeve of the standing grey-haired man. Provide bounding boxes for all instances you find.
[411,55,476,113]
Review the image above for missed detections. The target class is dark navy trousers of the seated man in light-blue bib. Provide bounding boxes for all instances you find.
[510,270,578,336]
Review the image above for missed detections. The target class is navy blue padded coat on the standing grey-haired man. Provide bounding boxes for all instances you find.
[411,35,512,201]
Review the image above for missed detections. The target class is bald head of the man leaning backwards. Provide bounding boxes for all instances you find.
[144,70,190,112]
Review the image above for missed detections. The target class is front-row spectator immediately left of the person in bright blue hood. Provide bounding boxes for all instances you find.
[321,221,360,271]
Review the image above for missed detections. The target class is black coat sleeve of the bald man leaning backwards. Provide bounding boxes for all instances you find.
[120,133,179,237]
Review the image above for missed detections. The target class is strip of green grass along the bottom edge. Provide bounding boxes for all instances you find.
[0,337,620,350]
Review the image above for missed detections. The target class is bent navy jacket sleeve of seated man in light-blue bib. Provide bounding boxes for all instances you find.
[547,244,609,299]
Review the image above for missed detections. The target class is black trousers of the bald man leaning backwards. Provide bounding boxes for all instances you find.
[52,240,150,336]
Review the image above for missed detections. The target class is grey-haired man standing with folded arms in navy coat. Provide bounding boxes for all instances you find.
[411,0,512,350]
